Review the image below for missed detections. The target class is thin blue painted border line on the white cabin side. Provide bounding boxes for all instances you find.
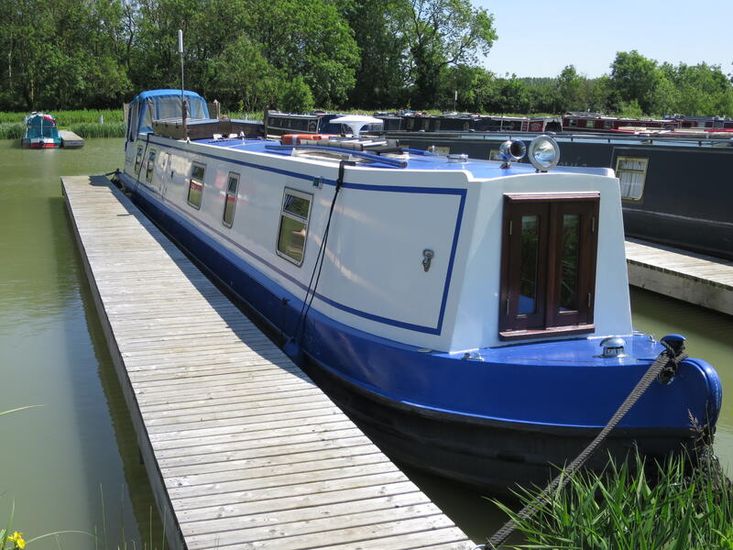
[137,140,467,335]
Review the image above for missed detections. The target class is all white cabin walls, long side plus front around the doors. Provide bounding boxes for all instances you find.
[125,135,632,352]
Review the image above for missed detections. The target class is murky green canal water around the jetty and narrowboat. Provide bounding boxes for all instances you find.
[0,139,733,550]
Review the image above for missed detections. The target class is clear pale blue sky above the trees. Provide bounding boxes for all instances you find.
[471,0,733,78]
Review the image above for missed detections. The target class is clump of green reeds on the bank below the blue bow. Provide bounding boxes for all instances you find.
[495,455,733,550]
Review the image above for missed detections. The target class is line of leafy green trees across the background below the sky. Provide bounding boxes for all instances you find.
[0,0,733,117]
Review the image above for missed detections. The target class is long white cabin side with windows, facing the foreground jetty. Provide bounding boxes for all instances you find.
[126,140,467,349]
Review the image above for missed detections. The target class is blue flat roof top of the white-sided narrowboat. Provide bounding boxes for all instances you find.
[187,138,613,179]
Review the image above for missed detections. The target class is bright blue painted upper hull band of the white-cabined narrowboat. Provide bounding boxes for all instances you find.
[124,179,720,438]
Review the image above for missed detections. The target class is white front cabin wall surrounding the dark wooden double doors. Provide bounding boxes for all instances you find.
[450,170,633,351]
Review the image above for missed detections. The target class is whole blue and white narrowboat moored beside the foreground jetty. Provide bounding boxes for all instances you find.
[118,90,722,488]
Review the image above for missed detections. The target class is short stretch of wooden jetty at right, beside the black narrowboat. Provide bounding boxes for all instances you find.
[626,239,733,315]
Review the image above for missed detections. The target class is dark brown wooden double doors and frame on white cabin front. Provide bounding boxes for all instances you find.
[499,192,600,340]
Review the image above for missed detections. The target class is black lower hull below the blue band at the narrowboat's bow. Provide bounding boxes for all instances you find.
[304,361,704,493]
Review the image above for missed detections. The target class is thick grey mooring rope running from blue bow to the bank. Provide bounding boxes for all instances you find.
[477,340,687,550]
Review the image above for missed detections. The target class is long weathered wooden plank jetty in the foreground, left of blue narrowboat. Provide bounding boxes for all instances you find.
[62,176,474,550]
